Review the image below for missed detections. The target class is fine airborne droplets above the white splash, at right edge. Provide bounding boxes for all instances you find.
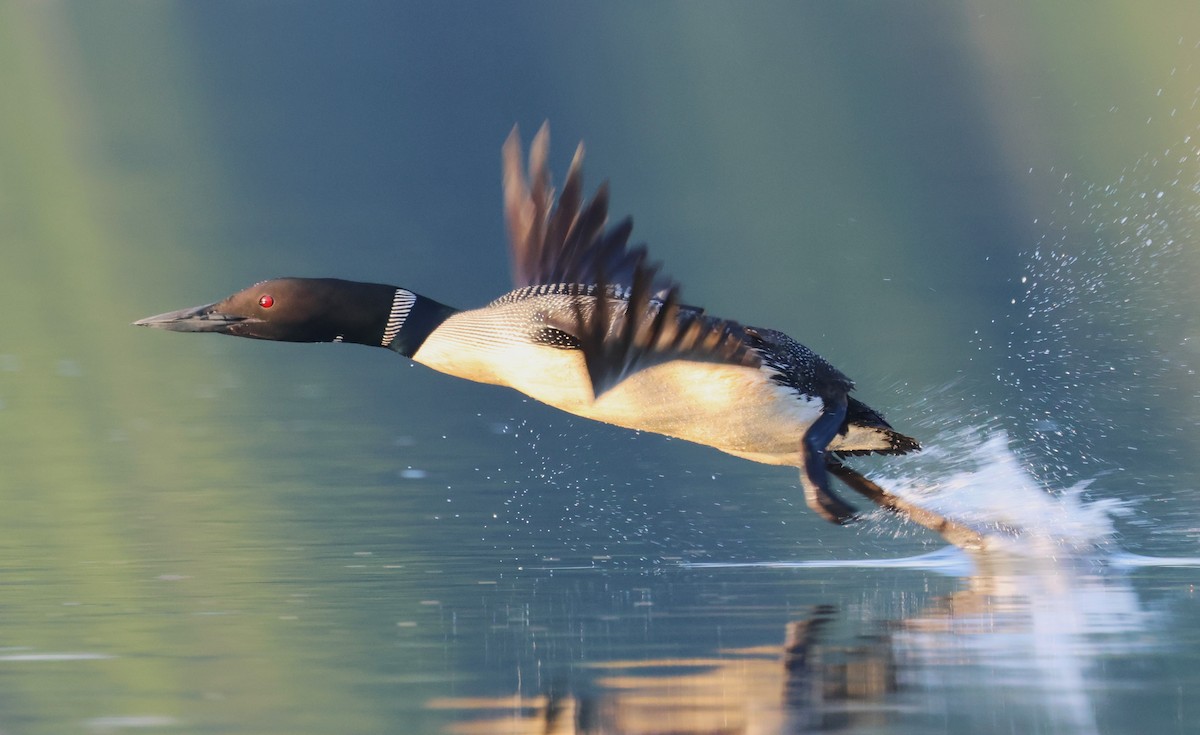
[988,132,1200,495]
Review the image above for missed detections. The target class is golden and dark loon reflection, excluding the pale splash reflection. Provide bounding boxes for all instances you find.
[428,605,896,735]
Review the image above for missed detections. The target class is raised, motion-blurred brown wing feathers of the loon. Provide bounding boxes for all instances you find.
[504,125,760,396]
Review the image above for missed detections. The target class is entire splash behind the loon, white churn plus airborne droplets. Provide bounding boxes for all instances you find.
[936,126,1200,554]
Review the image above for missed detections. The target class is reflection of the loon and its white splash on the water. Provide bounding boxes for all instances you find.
[427,555,1157,735]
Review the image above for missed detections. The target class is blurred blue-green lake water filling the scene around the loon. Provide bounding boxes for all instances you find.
[0,1,1200,735]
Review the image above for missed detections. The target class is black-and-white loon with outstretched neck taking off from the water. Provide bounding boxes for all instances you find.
[134,125,976,545]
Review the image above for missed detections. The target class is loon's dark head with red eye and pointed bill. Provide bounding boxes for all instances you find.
[134,279,400,345]
